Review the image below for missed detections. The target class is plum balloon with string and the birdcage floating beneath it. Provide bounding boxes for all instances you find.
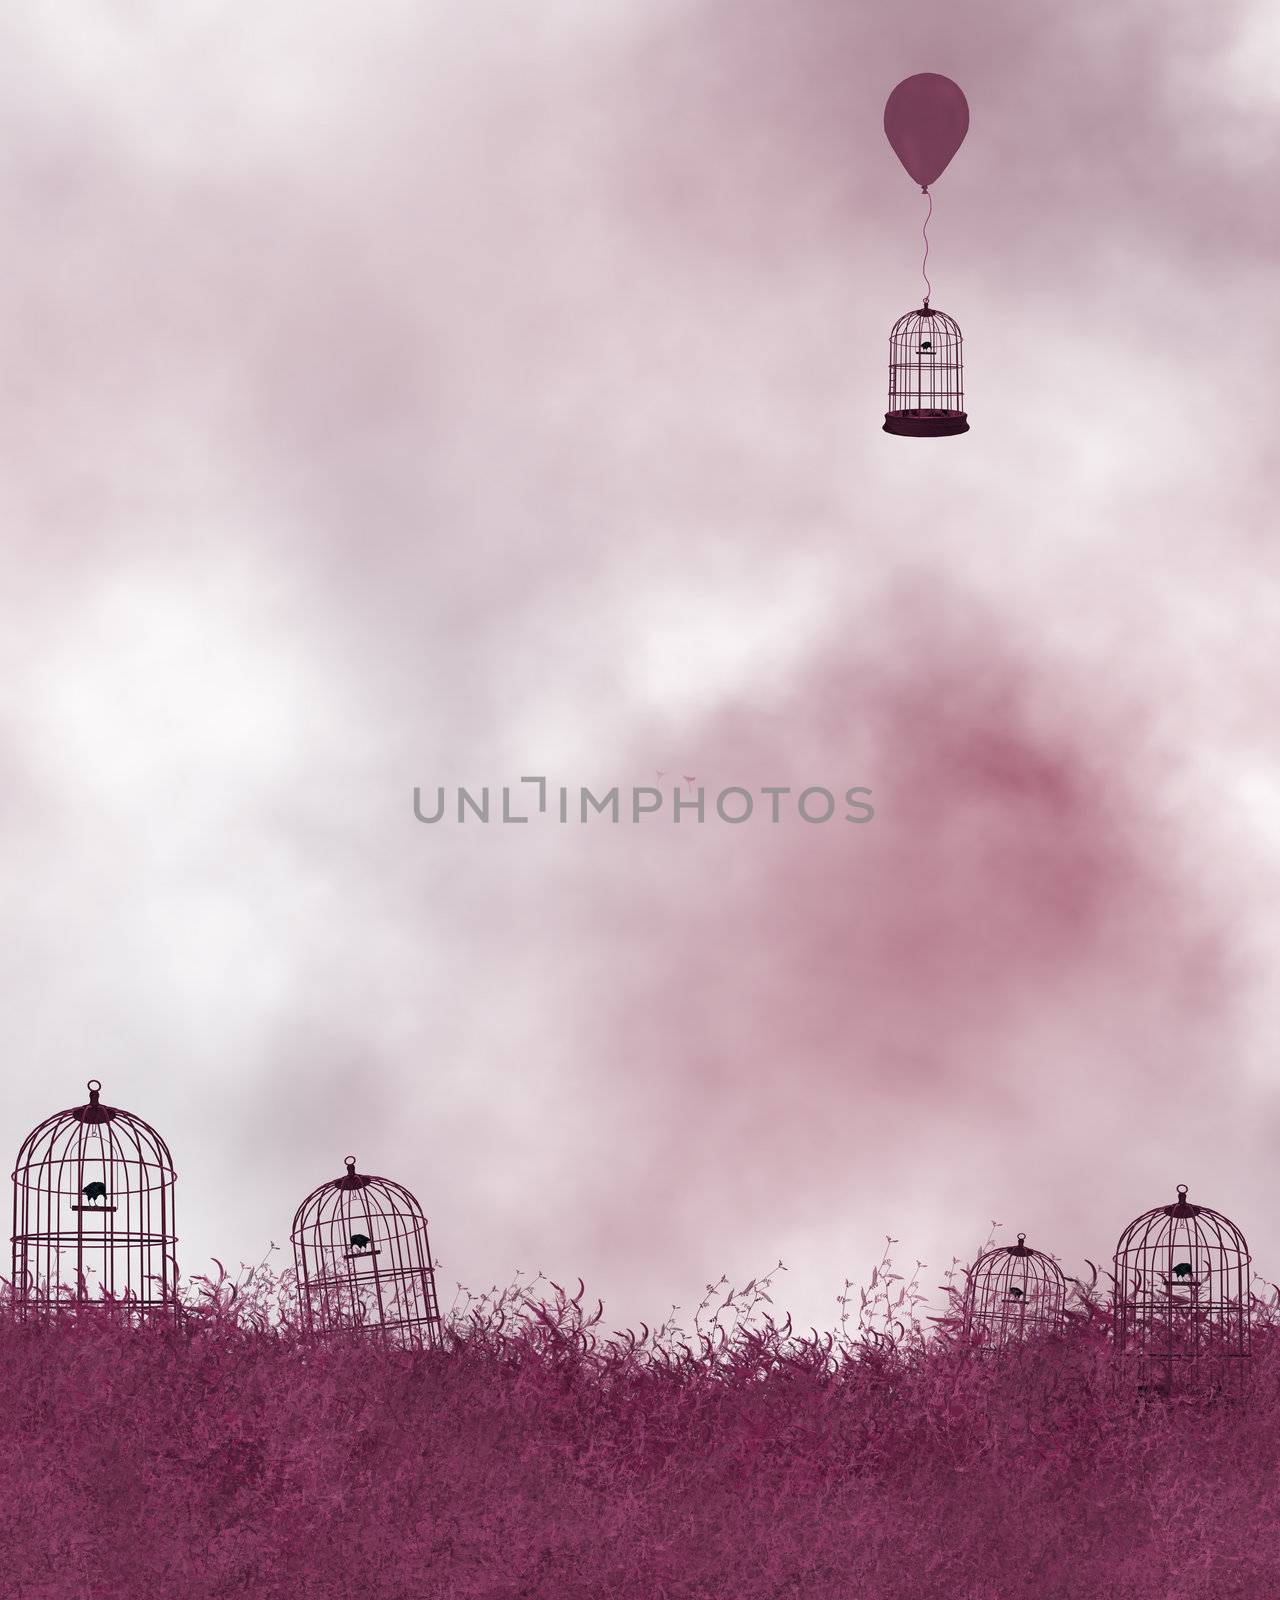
[885,72,970,438]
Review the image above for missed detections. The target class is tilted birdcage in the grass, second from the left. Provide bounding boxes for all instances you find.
[291,1155,440,1349]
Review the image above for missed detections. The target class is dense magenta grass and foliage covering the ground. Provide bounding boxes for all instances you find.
[0,1242,1280,1600]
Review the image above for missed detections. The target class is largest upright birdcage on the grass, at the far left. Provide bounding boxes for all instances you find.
[13,1078,178,1322]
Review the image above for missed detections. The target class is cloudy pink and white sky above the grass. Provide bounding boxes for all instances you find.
[0,0,1280,1326]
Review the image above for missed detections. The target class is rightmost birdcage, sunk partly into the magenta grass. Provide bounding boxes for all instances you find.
[1114,1184,1251,1394]
